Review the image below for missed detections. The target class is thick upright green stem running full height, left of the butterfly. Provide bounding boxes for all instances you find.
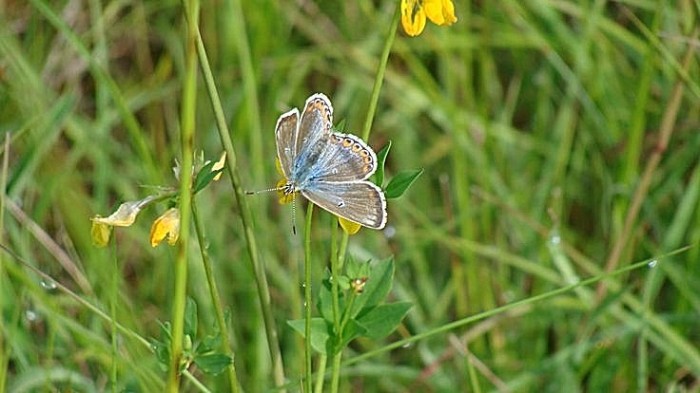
[167,0,199,393]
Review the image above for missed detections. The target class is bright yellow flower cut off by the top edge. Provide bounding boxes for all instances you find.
[401,0,457,37]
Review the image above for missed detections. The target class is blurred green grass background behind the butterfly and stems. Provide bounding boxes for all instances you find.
[0,0,700,392]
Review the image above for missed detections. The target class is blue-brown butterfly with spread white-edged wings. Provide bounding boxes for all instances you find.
[275,93,387,229]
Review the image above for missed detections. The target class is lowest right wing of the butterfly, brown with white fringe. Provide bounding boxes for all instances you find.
[301,181,387,229]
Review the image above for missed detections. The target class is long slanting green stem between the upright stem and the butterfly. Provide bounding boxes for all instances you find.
[197,19,285,387]
